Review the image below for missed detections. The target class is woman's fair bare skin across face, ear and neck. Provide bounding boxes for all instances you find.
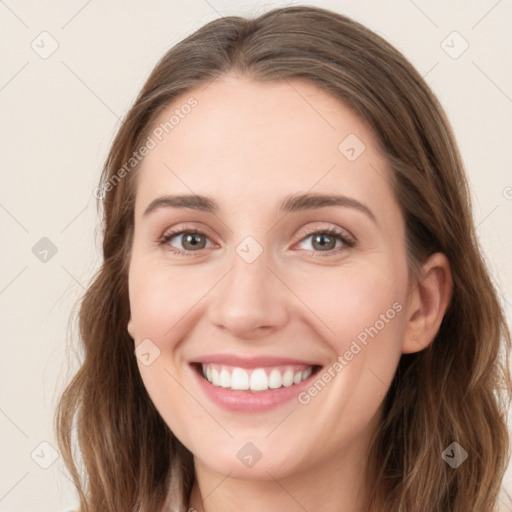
[128,73,452,512]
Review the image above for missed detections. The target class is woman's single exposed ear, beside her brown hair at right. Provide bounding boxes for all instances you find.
[402,252,453,354]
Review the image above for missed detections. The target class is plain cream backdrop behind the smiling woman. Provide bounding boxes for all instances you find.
[0,0,512,512]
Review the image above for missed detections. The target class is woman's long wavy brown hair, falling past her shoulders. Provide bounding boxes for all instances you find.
[55,6,512,512]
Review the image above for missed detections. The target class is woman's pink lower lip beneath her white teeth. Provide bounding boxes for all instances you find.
[192,368,318,412]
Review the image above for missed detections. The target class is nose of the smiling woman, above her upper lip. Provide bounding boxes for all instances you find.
[208,244,293,340]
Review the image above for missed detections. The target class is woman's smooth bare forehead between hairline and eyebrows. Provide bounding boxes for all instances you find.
[136,74,393,222]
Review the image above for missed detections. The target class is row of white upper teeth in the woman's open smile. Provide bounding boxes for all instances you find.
[201,364,313,391]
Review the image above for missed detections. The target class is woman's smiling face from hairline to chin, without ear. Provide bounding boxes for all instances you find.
[128,74,408,479]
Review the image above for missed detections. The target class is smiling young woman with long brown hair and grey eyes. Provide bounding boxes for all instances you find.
[56,7,511,512]
